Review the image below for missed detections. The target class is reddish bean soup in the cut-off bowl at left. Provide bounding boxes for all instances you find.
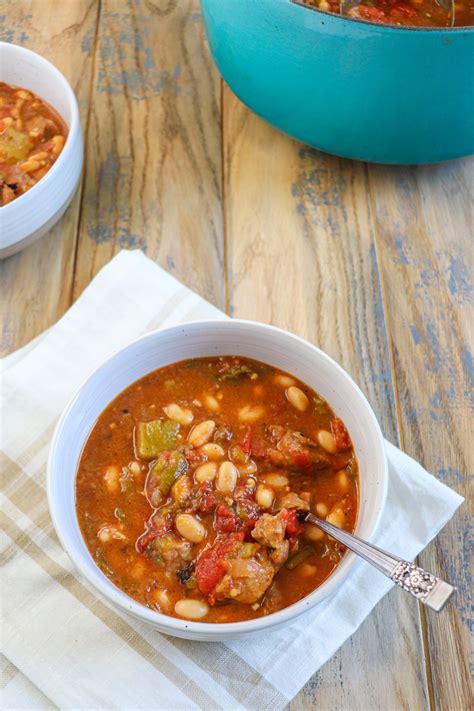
[0,82,68,206]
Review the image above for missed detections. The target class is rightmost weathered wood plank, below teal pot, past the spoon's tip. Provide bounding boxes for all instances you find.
[369,159,474,711]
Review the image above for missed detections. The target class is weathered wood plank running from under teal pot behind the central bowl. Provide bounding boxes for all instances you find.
[224,89,428,711]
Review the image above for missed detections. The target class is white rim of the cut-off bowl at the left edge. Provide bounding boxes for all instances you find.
[0,41,80,214]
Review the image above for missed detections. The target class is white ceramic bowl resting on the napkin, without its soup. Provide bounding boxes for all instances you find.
[48,320,387,641]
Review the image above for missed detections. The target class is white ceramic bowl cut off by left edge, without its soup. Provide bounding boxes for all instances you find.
[0,42,83,259]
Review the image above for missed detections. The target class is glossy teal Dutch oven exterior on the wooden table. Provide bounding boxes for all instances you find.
[201,0,474,163]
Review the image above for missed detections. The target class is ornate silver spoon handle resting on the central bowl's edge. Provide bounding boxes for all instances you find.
[300,512,456,612]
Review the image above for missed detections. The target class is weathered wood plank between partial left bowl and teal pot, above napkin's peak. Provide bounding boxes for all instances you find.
[74,0,224,305]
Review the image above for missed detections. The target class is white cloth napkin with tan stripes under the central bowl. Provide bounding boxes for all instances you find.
[0,252,463,711]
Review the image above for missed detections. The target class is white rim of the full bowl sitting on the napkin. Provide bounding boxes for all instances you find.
[46,319,388,641]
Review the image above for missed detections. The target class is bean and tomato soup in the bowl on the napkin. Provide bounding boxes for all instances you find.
[76,356,358,623]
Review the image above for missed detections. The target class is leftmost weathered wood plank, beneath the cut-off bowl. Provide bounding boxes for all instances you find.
[0,0,98,355]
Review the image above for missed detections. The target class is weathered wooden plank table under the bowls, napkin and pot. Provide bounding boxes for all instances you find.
[0,0,473,711]
